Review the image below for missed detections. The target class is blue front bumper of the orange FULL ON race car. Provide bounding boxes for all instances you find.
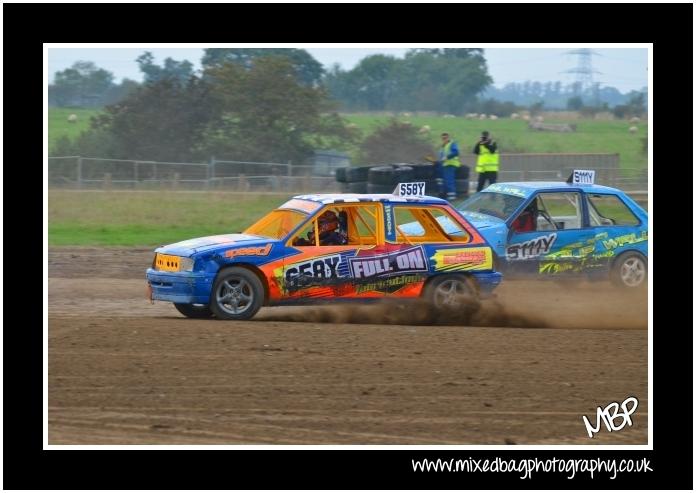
[145,269,215,304]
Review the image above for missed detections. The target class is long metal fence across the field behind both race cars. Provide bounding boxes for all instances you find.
[48,154,648,193]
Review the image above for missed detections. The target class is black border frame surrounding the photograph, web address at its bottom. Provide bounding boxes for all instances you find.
[2,4,693,489]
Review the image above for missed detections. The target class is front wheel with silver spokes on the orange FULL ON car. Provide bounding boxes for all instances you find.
[210,267,264,320]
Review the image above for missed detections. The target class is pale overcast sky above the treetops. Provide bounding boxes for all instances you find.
[48,46,648,92]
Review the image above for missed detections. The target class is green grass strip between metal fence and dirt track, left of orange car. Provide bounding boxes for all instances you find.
[48,190,288,246]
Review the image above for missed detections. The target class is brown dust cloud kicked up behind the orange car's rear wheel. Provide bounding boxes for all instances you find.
[254,281,648,330]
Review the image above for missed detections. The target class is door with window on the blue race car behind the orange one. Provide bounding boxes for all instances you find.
[505,190,593,277]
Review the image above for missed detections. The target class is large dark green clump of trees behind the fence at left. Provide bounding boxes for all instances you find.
[53,49,357,163]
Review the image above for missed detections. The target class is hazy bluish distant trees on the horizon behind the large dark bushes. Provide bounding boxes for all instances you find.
[48,48,647,116]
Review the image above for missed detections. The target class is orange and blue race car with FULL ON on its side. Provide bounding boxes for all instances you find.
[147,183,502,320]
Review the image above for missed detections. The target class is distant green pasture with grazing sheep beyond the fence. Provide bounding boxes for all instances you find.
[48,108,648,170]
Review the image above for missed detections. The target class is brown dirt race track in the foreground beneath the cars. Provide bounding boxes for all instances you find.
[48,248,648,444]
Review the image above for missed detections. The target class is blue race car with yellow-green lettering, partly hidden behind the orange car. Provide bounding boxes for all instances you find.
[456,175,648,288]
